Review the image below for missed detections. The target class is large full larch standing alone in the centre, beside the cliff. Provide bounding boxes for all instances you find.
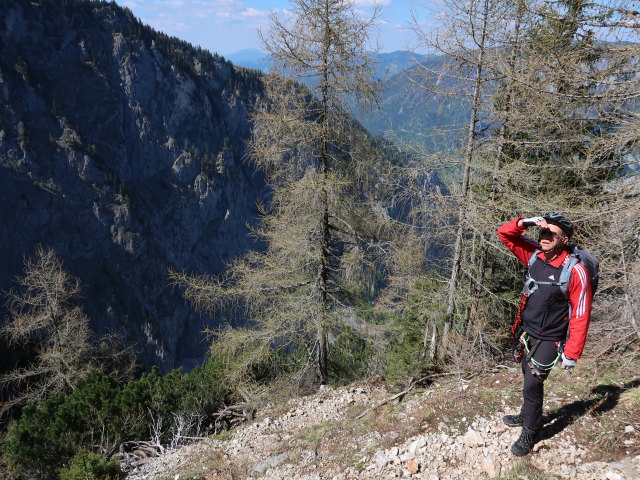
[168,0,385,390]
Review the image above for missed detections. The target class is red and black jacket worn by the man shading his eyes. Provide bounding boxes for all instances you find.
[498,217,591,360]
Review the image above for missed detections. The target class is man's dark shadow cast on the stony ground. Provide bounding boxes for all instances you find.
[540,378,640,440]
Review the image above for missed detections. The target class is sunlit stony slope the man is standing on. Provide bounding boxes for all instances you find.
[122,361,640,480]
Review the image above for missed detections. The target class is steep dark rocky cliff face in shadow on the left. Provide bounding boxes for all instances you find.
[0,0,266,370]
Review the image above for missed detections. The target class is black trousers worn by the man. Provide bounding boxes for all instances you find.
[520,338,558,432]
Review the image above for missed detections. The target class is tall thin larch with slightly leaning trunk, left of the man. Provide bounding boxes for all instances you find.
[404,0,522,360]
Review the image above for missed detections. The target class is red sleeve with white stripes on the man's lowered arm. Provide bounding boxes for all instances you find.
[564,263,591,360]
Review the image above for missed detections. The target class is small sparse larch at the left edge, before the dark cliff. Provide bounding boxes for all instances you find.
[0,247,96,414]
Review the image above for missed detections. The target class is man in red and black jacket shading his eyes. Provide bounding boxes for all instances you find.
[498,213,591,456]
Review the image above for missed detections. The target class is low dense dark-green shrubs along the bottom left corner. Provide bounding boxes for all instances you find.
[0,365,225,479]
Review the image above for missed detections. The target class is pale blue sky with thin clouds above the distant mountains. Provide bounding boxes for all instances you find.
[116,0,436,55]
